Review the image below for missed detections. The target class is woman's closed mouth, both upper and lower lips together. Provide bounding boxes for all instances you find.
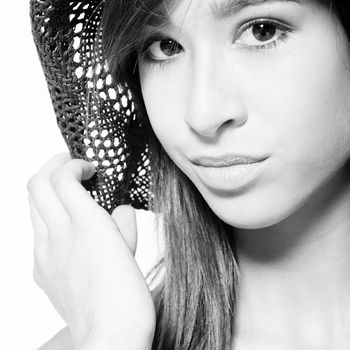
[193,157,268,192]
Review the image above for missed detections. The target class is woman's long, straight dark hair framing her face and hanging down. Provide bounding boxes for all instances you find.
[102,0,350,350]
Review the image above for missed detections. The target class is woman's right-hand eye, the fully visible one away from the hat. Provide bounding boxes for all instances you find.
[235,19,291,49]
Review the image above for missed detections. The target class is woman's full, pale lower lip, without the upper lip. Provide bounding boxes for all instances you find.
[196,159,266,192]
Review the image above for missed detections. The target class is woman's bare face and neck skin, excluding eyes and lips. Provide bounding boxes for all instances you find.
[139,0,350,350]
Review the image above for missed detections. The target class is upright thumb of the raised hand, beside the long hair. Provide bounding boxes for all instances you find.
[111,205,137,256]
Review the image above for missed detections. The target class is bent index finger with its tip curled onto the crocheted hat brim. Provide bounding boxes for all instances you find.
[51,159,99,221]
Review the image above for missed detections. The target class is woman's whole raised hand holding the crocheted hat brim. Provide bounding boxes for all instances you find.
[27,153,155,349]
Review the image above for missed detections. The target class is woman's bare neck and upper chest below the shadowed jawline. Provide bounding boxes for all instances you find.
[234,164,350,349]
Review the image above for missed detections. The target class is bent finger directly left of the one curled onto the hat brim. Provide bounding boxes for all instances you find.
[27,153,71,227]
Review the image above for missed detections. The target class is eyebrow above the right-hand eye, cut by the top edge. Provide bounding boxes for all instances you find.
[211,0,300,19]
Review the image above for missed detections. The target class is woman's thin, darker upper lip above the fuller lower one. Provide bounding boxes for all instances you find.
[191,154,268,167]
